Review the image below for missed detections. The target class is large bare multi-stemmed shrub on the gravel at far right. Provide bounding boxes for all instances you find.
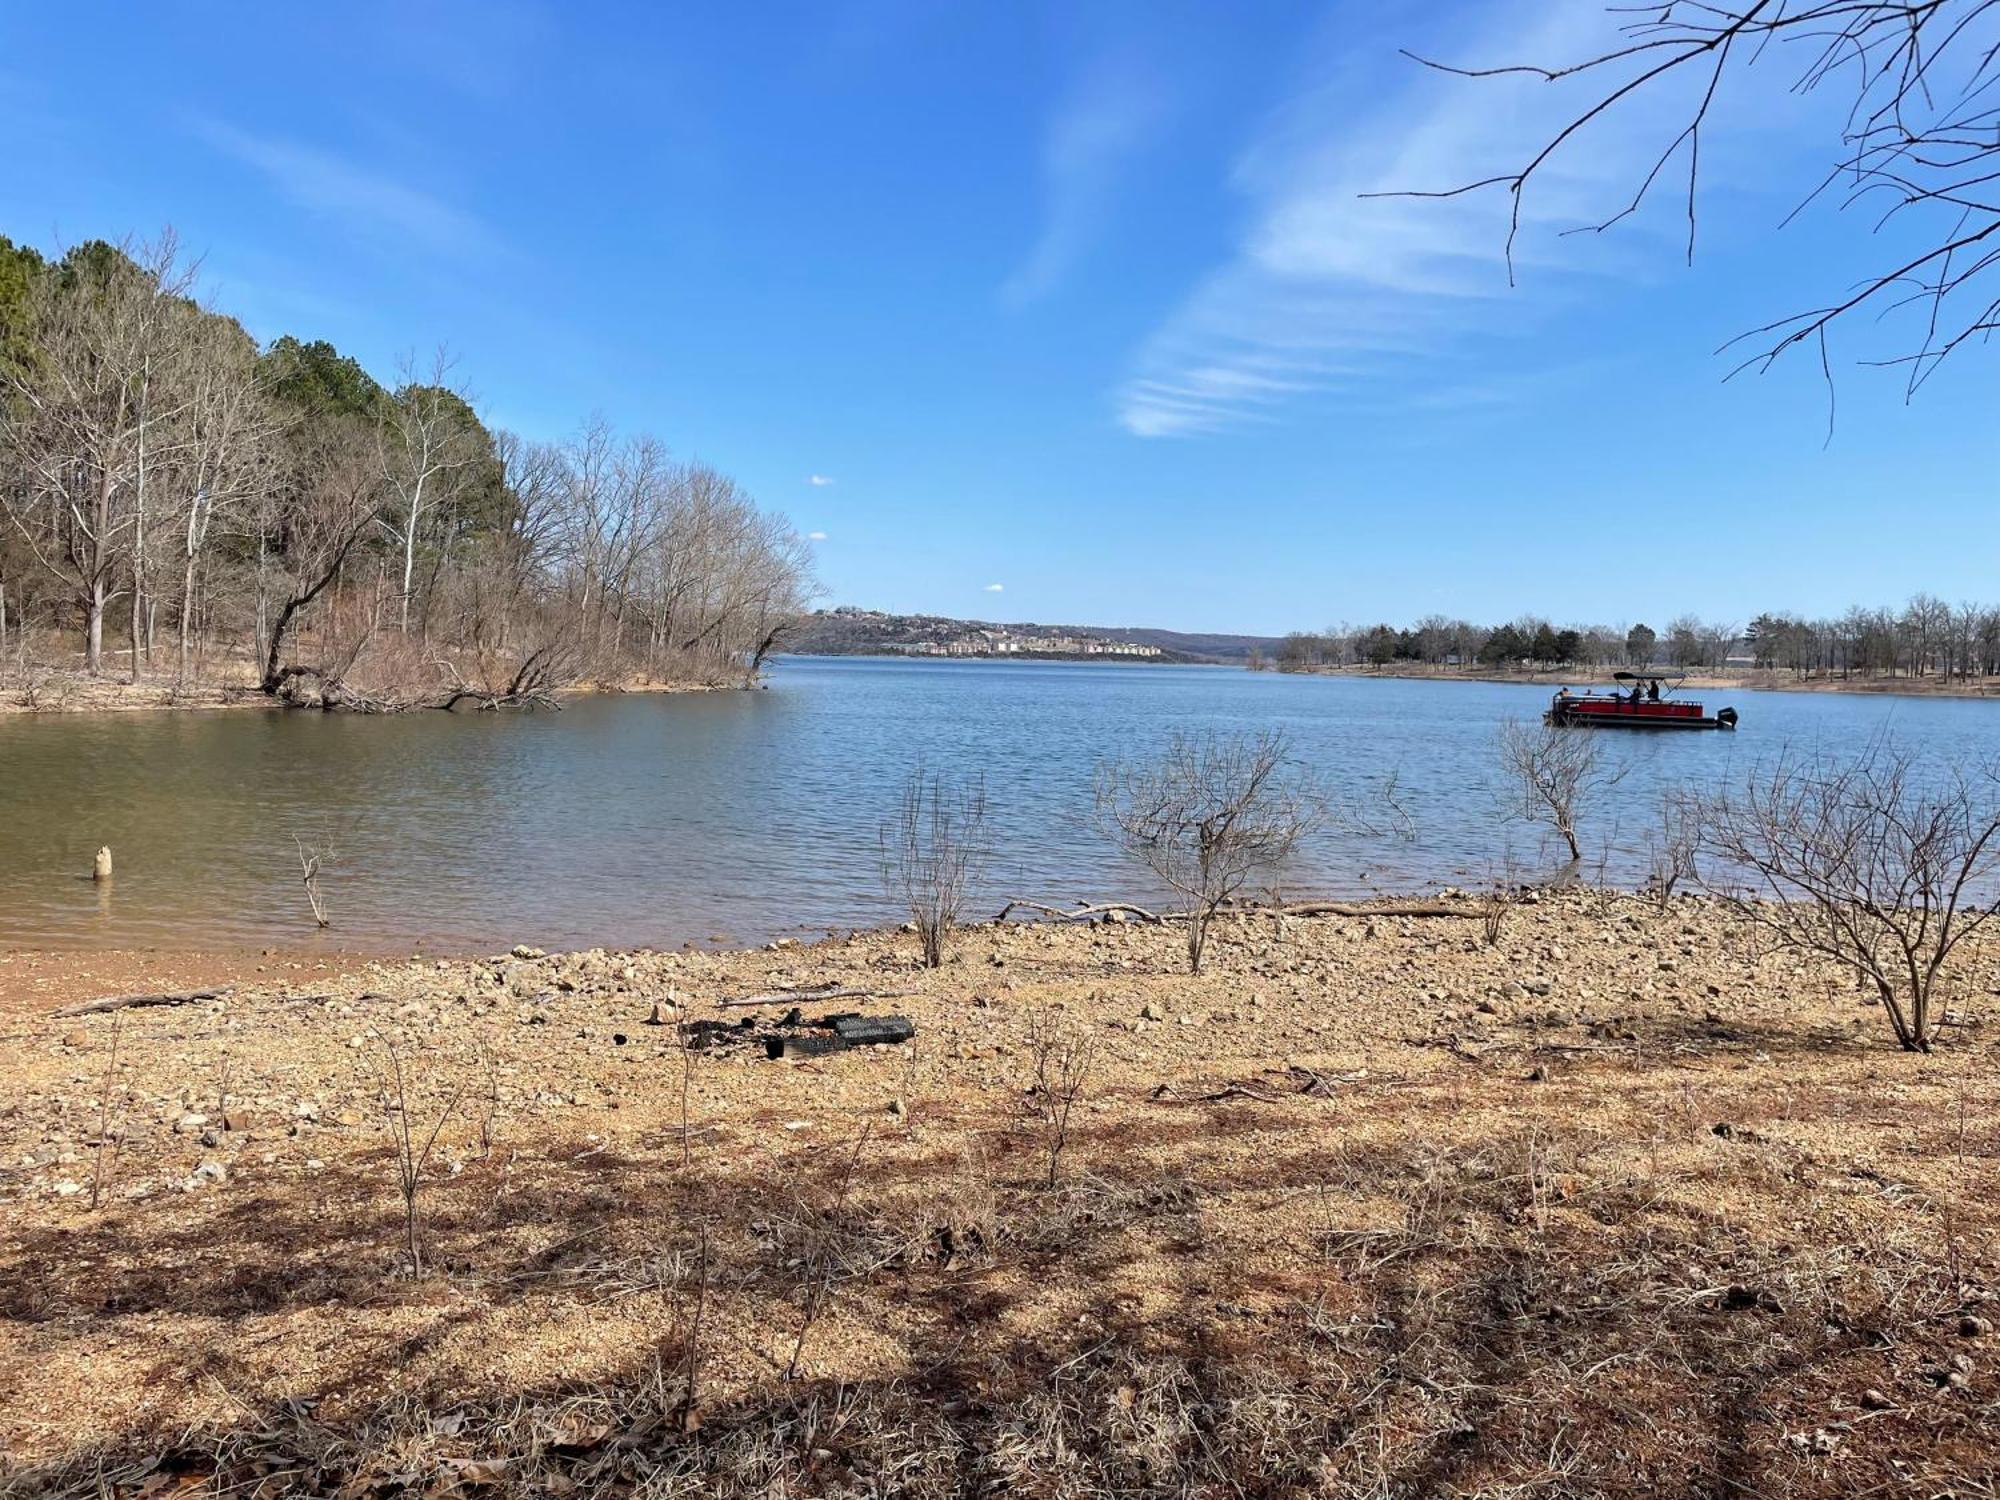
[1700,742,2000,1052]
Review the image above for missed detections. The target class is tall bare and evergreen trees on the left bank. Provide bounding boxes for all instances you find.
[0,236,814,708]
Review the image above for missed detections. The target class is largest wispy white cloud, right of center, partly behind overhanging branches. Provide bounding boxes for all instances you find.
[1116,0,1696,438]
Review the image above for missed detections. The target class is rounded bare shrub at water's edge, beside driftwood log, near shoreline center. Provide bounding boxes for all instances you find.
[1096,730,1324,974]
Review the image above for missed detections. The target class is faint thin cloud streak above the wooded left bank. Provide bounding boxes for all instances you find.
[194,120,502,254]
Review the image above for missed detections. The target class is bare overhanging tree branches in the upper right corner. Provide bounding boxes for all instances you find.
[1406,0,2000,406]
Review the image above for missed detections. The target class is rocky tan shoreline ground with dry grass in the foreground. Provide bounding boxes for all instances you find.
[0,892,2000,1496]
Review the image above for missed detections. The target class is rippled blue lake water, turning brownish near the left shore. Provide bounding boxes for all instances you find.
[0,658,2000,952]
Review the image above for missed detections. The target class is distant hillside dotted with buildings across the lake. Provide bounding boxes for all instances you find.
[788,606,1278,662]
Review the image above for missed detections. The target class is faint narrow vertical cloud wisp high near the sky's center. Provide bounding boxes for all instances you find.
[1000,58,1166,306]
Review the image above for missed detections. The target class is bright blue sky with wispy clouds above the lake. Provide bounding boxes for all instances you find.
[0,0,2000,632]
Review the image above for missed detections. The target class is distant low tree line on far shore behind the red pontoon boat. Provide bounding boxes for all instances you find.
[1270,594,2000,678]
